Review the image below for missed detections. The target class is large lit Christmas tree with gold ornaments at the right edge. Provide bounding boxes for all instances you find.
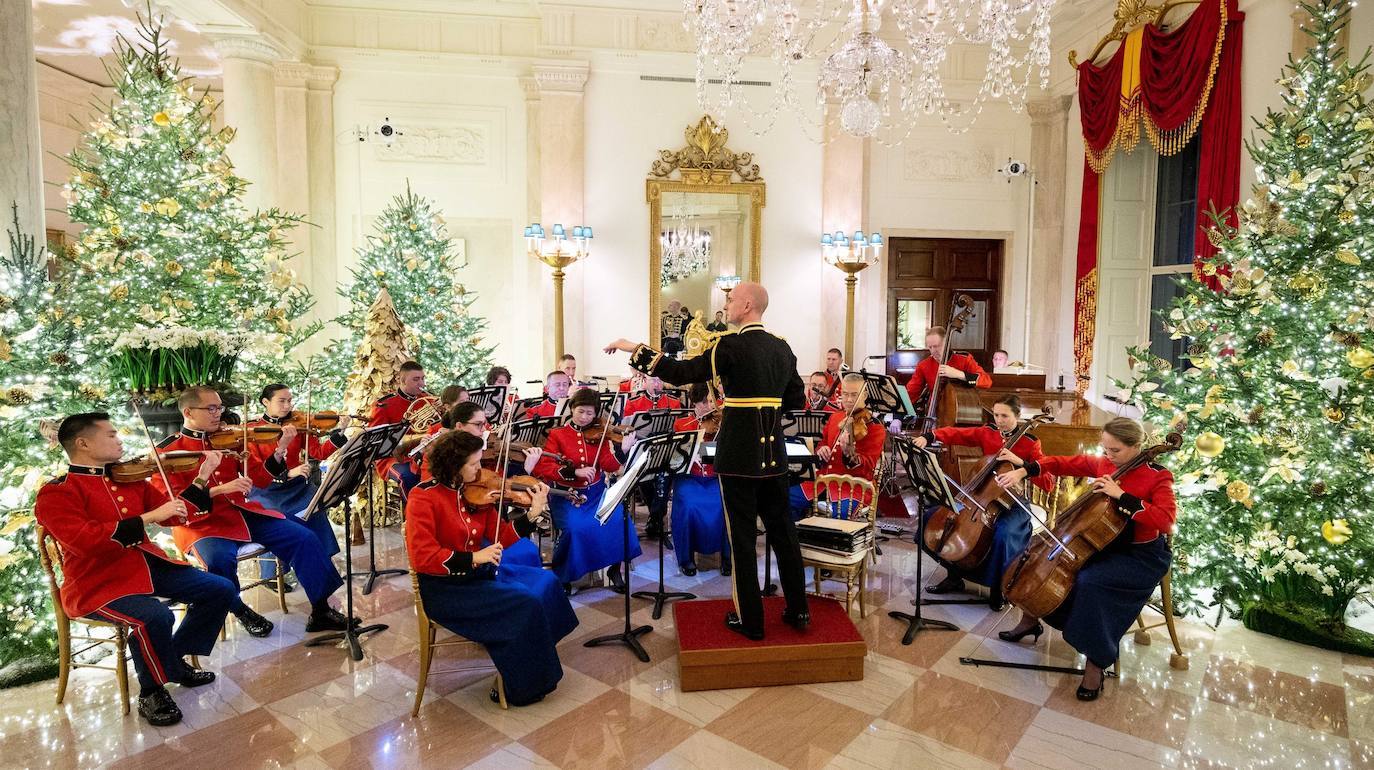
[1125,0,1374,655]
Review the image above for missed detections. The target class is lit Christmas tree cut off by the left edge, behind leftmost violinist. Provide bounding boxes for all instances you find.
[0,202,104,685]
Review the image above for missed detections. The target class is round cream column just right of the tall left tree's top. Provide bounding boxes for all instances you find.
[214,37,282,209]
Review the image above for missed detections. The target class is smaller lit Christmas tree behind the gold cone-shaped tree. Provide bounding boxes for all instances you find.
[319,184,495,393]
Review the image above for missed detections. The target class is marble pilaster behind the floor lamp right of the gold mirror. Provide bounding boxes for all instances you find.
[818,102,886,370]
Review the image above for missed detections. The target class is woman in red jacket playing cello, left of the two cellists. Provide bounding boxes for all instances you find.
[915,393,1054,612]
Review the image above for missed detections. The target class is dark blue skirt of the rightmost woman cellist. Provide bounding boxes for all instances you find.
[1044,536,1172,668]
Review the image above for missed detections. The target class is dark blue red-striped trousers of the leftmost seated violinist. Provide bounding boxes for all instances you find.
[87,554,239,694]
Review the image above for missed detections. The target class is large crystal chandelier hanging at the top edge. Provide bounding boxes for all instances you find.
[684,0,1054,136]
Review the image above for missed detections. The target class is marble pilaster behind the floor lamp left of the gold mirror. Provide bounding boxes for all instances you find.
[529,61,596,367]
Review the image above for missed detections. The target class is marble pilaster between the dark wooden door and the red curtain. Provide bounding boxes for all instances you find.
[1011,96,1073,374]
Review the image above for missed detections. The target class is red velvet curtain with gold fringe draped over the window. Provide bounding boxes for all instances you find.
[1073,0,1243,393]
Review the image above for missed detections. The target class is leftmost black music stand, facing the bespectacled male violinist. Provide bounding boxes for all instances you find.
[301,424,405,660]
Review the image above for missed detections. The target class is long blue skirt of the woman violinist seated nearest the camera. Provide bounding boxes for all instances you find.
[419,564,577,705]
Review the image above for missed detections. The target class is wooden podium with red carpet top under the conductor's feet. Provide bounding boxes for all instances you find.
[673,597,868,692]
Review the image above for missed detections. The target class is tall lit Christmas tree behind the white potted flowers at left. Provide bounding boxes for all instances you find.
[62,17,317,378]
